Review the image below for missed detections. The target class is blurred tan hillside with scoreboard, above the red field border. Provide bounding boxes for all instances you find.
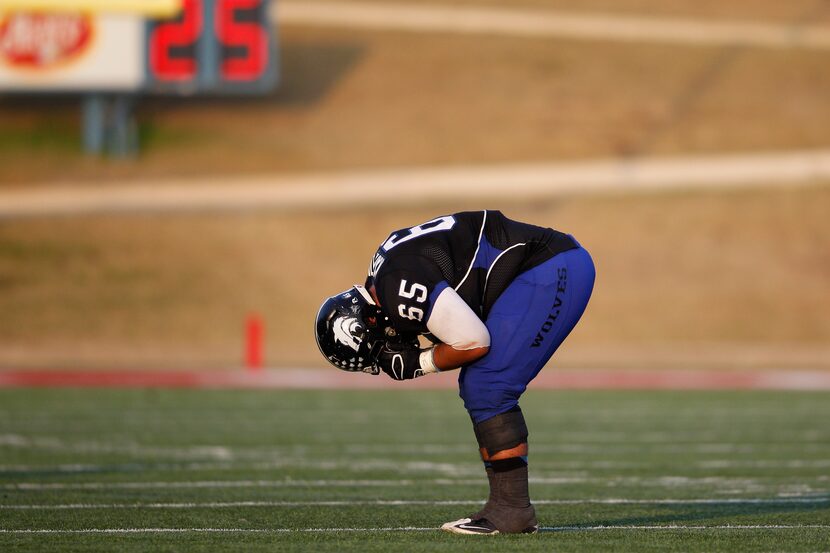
[0,0,830,376]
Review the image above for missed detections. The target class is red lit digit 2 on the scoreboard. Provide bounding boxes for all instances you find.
[149,0,204,81]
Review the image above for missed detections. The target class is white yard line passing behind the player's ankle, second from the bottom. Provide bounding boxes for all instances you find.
[0,497,830,511]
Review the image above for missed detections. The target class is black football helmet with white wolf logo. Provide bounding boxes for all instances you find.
[314,284,387,374]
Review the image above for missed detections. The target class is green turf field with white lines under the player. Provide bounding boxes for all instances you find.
[0,387,830,552]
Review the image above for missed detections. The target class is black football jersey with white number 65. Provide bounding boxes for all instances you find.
[366,210,578,334]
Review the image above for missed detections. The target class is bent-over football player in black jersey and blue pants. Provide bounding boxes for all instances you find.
[315,211,595,534]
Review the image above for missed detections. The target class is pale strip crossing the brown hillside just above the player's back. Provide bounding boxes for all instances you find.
[0,150,830,220]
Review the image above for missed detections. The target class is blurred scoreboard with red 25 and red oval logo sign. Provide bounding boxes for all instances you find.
[0,0,278,95]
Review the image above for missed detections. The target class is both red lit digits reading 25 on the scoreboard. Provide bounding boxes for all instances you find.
[147,0,272,88]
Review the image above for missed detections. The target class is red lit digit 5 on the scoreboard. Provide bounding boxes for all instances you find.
[216,0,268,81]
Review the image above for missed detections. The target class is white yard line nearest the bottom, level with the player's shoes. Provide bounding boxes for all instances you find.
[0,524,830,534]
